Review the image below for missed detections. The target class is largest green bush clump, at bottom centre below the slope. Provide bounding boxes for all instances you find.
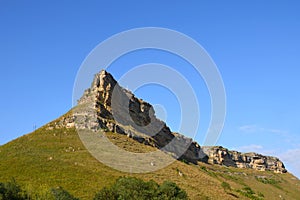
[94,177,188,200]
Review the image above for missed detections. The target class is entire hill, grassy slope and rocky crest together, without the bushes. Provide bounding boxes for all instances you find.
[0,71,300,200]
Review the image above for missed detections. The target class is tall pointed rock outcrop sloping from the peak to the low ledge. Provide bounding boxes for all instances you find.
[74,70,203,164]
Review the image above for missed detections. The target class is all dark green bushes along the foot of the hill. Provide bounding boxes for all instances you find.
[0,177,188,200]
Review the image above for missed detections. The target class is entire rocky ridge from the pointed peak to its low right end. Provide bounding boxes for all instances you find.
[69,70,286,173]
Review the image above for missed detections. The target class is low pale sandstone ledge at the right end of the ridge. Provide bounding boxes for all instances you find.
[202,146,287,173]
